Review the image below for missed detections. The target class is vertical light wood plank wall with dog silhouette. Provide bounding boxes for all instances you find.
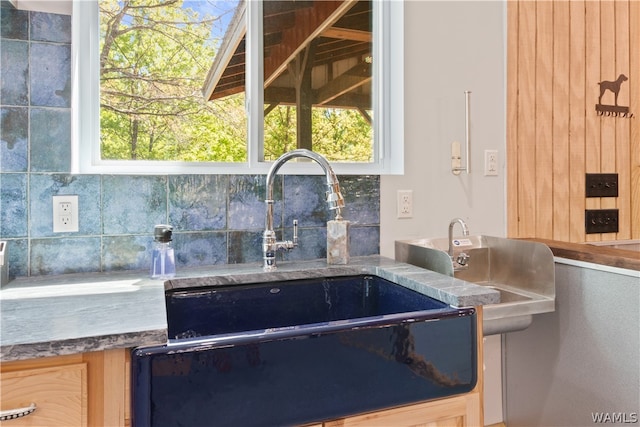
[507,0,640,242]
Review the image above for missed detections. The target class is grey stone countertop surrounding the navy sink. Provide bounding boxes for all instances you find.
[0,256,500,362]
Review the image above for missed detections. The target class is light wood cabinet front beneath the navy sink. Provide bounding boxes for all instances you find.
[324,393,480,427]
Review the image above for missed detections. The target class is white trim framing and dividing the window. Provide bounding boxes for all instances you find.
[71,0,404,175]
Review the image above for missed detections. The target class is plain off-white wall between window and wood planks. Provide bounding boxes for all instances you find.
[380,1,506,257]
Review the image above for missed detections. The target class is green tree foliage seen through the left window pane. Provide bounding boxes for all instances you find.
[99,0,247,162]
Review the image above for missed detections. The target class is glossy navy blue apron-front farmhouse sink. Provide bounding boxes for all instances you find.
[132,275,477,427]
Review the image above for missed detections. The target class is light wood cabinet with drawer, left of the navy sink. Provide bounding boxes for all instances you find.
[0,349,129,427]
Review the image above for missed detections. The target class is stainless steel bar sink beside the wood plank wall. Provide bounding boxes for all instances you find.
[395,235,555,335]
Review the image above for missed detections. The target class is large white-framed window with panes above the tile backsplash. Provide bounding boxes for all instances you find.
[72,0,403,174]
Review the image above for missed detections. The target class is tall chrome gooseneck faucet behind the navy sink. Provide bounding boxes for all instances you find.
[262,148,344,271]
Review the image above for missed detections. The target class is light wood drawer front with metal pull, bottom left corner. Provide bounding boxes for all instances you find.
[0,363,87,427]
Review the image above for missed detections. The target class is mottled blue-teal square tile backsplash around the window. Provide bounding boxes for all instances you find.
[0,1,380,277]
